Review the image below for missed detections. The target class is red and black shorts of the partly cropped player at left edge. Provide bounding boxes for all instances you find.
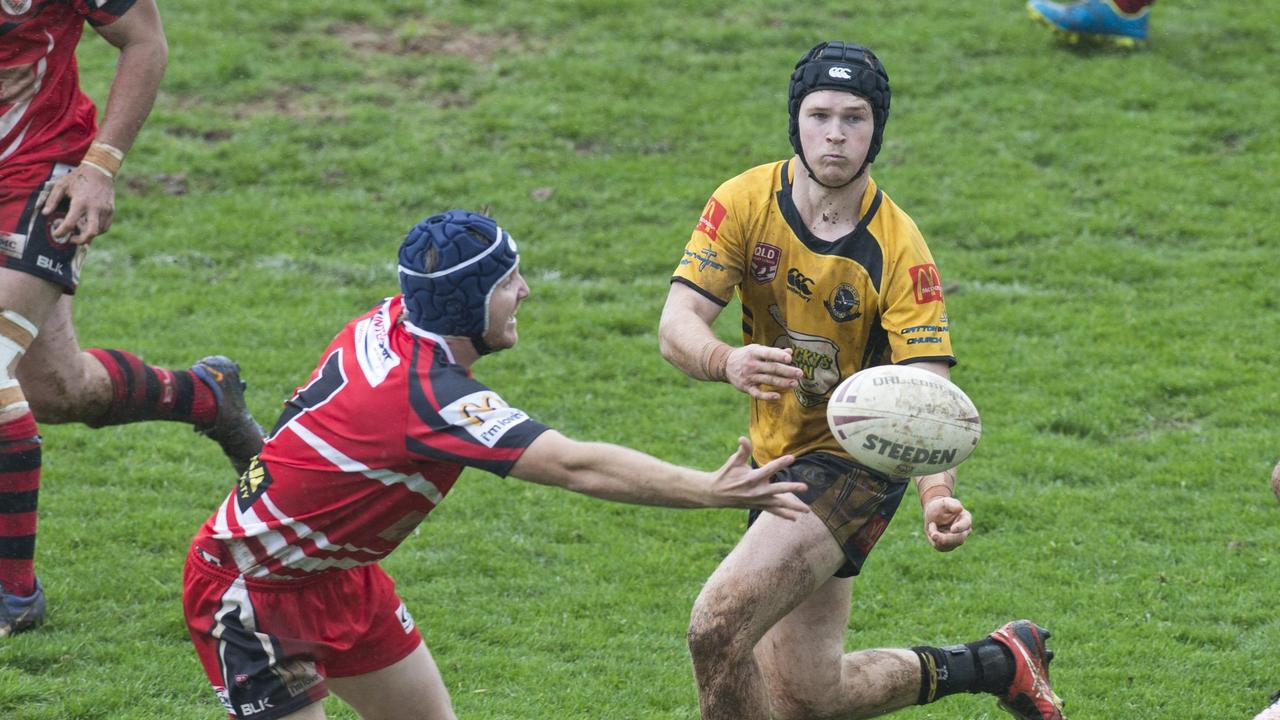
[0,163,88,293]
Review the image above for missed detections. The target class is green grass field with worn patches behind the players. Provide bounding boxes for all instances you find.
[0,0,1280,720]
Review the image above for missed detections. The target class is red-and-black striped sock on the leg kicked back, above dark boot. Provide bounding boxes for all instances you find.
[86,347,218,428]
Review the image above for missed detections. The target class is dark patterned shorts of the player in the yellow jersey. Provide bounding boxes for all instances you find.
[748,452,910,578]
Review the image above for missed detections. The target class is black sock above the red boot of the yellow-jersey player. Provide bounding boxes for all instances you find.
[911,638,1014,705]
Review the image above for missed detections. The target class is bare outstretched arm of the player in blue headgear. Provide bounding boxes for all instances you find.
[511,430,809,520]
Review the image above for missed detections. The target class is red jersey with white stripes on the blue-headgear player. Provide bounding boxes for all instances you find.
[195,296,548,579]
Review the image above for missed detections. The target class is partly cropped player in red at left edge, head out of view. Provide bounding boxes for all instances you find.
[0,0,261,638]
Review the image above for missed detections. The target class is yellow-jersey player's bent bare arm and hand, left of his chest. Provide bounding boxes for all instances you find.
[658,283,804,400]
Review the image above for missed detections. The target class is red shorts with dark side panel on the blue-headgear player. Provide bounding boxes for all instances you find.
[182,546,422,720]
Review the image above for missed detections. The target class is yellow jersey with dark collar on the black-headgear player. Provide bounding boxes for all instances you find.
[672,160,955,464]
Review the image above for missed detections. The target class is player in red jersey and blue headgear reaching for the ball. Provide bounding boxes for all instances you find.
[183,210,806,720]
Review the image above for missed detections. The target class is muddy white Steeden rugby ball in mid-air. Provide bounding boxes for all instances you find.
[827,365,982,478]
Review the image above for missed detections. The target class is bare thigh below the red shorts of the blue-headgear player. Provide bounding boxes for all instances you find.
[325,644,456,720]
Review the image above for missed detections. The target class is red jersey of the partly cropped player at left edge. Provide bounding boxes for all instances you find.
[0,0,134,167]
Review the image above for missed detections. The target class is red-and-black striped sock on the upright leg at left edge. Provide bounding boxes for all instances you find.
[0,413,40,596]
